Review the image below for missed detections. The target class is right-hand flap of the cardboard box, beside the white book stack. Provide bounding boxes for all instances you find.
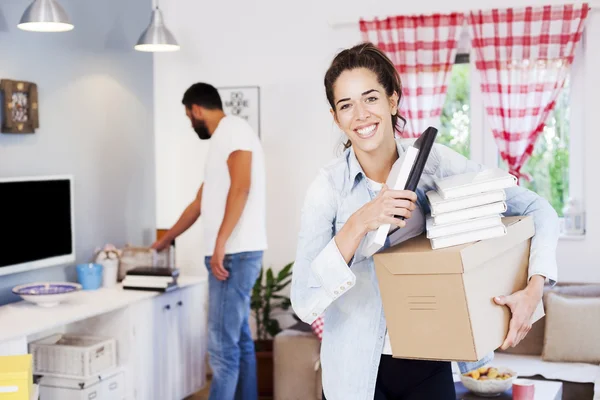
[461,216,535,272]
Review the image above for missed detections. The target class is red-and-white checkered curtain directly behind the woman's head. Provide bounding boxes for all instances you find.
[359,13,464,137]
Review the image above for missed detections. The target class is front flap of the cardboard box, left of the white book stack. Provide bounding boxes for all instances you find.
[373,238,466,275]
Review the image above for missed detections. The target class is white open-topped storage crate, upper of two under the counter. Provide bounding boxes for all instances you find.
[29,334,117,379]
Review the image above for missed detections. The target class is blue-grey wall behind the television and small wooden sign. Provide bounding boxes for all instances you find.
[0,0,155,304]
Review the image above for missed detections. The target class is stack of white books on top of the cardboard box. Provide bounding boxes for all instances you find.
[425,168,517,249]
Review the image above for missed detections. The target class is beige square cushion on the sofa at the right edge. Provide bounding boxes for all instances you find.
[542,292,600,364]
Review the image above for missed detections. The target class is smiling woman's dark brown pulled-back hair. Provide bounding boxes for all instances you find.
[325,42,406,149]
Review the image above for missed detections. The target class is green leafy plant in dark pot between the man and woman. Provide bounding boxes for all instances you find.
[250,263,293,396]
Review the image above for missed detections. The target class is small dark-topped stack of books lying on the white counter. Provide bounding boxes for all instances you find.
[123,267,179,292]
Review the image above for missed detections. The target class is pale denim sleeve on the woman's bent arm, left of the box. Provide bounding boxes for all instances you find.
[291,170,356,324]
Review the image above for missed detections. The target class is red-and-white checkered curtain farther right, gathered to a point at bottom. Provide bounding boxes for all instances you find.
[468,4,589,179]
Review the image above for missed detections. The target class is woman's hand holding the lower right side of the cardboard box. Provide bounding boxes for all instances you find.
[494,275,545,350]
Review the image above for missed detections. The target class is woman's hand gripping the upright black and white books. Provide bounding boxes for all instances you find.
[353,185,417,234]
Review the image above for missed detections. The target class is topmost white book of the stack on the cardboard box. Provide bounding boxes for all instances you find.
[434,168,517,200]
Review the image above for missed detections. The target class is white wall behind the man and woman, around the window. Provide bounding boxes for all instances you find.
[154,0,600,282]
